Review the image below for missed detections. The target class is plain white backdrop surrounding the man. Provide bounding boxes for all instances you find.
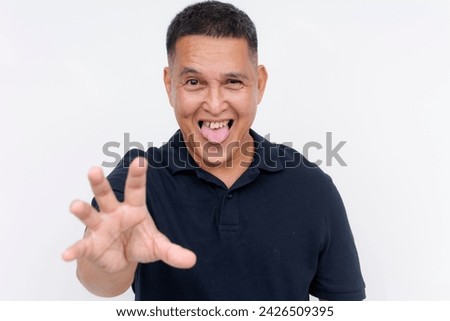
[0,0,450,300]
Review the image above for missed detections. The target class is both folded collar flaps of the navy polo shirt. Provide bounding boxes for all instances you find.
[162,129,285,174]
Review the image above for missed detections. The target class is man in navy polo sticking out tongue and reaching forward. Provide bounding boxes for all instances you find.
[63,1,365,300]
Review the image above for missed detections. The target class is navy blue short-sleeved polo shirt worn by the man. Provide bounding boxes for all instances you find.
[104,131,365,300]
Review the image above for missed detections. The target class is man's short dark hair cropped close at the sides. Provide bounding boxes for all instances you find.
[166,1,258,60]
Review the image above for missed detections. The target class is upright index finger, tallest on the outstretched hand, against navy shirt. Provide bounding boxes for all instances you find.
[125,157,148,206]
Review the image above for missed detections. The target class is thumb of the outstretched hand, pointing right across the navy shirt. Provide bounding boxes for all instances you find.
[154,234,197,269]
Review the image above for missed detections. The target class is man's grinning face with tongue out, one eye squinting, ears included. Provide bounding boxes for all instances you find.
[164,36,267,166]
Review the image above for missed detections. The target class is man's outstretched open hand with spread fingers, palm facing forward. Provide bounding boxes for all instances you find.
[63,157,196,273]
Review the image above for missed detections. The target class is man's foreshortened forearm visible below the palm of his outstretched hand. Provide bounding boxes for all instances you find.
[77,258,137,297]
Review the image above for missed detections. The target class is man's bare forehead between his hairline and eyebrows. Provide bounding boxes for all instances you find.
[169,35,254,65]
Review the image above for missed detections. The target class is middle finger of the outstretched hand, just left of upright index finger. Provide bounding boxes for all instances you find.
[88,167,119,213]
